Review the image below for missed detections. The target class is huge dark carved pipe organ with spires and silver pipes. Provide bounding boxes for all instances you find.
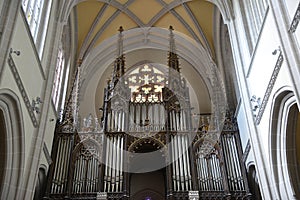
[45,27,251,200]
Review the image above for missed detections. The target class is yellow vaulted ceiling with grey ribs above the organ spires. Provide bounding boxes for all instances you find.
[76,0,215,58]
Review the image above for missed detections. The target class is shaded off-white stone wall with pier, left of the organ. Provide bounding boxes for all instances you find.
[0,1,61,199]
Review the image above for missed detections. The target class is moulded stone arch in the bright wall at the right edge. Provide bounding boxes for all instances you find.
[270,88,299,199]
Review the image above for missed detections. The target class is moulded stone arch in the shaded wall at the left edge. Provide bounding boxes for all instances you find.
[0,89,25,199]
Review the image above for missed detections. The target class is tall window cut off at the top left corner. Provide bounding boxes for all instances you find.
[22,0,52,58]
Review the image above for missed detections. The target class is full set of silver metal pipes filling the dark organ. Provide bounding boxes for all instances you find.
[46,58,251,199]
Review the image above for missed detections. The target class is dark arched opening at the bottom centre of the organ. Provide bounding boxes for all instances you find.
[129,140,166,200]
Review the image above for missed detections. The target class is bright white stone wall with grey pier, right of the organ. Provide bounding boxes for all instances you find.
[228,0,300,199]
